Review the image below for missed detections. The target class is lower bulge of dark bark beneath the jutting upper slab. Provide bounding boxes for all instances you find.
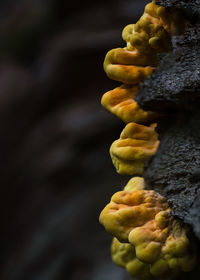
[145,116,200,236]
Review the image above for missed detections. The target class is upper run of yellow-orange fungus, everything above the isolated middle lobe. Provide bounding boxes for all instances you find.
[102,2,185,123]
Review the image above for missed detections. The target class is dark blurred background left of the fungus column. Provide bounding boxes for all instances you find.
[0,0,149,280]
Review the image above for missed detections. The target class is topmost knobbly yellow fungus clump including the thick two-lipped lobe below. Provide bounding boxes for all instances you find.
[104,3,185,85]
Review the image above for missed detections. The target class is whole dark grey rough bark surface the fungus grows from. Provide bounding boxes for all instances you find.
[137,1,200,243]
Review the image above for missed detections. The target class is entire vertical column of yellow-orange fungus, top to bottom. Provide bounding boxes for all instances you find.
[99,2,196,279]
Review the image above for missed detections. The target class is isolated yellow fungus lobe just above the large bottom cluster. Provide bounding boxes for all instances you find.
[110,122,159,175]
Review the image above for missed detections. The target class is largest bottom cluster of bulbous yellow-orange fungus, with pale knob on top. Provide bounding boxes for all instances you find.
[100,177,196,279]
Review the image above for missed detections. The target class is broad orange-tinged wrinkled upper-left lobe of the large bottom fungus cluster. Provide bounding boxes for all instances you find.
[99,180,168,242]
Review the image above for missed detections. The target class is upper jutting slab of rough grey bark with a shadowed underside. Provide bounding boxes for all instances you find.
[136,23,200,113]
